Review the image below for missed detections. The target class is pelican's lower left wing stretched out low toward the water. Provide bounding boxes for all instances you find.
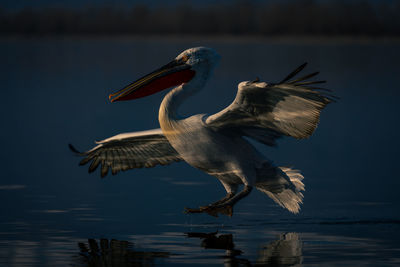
[69,129,182,177]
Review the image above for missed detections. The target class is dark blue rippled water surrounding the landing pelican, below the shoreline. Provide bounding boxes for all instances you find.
[0,38,400,266]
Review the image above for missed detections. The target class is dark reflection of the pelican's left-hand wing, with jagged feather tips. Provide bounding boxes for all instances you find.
[77,239,169,267]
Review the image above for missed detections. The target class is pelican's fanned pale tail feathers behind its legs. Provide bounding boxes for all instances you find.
[256,167,305,213]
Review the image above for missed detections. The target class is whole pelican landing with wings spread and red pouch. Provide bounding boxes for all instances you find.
[70,47,334,216]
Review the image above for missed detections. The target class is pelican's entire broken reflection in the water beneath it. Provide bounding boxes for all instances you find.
[73,232,302,267]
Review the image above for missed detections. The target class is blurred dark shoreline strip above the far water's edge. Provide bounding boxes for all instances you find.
[0,0,400,37]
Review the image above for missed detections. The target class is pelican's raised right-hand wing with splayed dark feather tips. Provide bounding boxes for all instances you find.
[206,63,335,145]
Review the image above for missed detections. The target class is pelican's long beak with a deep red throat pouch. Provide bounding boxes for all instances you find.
[109,60,195,102]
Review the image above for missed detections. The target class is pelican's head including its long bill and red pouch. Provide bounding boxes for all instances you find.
[109,47,220,102]
